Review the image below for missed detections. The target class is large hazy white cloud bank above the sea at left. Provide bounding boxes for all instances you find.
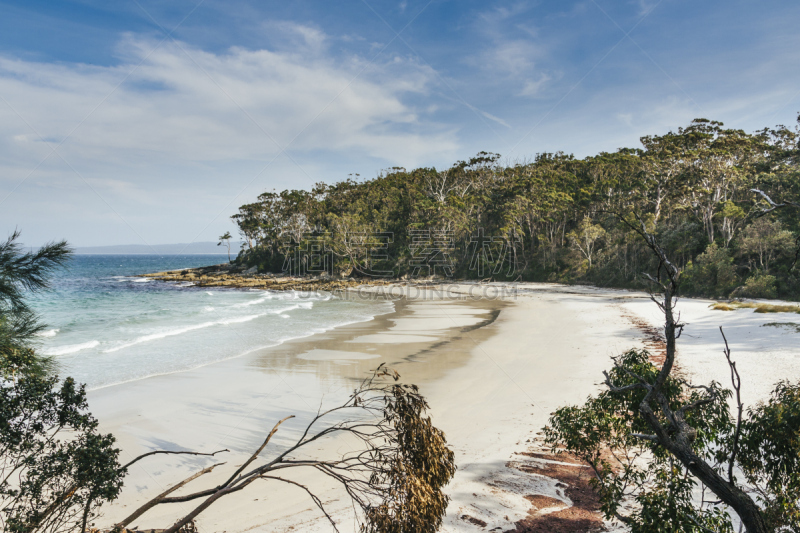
[0,29,460,245]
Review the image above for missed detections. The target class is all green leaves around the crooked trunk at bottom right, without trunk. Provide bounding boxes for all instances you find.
[545,350,800,533]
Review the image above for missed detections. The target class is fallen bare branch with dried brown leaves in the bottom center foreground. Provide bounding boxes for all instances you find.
[113,365,455,533]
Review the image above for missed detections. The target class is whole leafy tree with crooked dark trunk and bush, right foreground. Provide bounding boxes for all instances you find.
[545,201,800,533]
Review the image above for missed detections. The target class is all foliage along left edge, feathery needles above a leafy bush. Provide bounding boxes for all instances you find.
[0,232,125,533]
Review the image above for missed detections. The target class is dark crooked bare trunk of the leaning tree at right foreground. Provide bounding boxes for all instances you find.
[604,213,769,533]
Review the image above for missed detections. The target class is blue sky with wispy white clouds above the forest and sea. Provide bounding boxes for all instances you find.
[0,0,800,246]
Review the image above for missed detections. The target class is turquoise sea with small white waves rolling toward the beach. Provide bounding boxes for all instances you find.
[32,255,391,389]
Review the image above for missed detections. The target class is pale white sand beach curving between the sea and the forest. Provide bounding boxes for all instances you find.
[89,283,800,533]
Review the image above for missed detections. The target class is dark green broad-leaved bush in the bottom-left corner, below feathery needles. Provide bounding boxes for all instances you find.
[0,374,125,533]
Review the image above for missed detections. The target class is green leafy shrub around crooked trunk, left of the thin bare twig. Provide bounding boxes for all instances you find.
[545,350,733,533]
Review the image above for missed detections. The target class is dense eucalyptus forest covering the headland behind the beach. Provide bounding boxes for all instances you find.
[232,119,800,298]
